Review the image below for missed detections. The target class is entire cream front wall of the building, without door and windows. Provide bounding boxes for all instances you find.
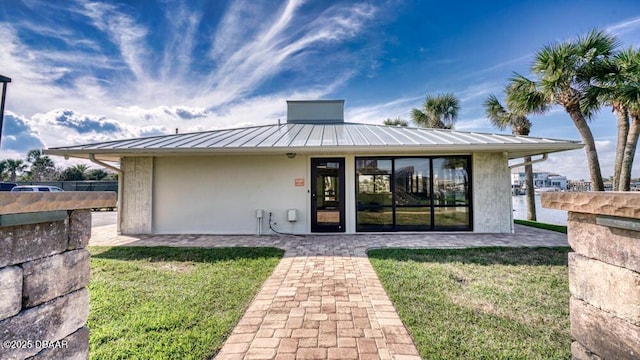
[121,153,512,234]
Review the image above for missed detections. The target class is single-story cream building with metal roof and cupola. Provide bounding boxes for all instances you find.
[45,100,582,234]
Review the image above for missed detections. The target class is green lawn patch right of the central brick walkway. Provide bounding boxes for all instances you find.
[369,248,571,359]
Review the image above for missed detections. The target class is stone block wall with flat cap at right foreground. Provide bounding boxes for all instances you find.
[542,192,640,359]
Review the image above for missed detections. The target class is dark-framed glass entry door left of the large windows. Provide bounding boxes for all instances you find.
[311,158,345,232]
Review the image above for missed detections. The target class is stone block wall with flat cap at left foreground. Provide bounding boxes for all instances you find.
[0,192,115,359]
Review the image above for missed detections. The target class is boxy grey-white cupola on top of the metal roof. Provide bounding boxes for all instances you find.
[287,100,344,124]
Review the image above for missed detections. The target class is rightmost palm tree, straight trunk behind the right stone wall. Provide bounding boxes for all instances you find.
[587,48,640,191]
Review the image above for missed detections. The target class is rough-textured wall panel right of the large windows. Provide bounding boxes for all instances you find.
[473,153,512,233]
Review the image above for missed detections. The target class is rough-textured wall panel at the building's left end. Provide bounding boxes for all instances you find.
[119,157,153,234]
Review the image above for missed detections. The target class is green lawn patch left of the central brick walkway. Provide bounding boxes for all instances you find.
[88,247,284,359]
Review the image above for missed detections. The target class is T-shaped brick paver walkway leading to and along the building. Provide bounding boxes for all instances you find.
[90,226,568,360]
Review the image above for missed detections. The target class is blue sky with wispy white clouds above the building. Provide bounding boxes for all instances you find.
[0,0,640,179]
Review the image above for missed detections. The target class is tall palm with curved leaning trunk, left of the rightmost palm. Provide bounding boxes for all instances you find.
[507,30,618,191]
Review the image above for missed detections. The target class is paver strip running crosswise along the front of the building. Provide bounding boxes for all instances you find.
[89,225,569,253]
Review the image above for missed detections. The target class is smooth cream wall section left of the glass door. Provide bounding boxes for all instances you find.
[153,154,309,234]
